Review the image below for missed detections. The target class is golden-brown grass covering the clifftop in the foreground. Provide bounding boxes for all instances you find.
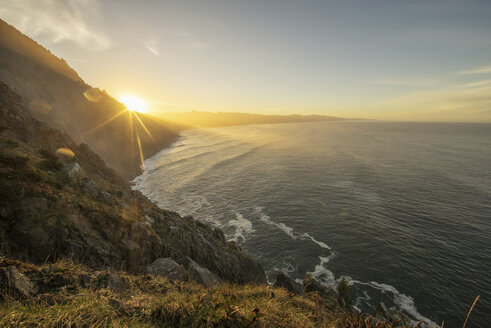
[0,258,408,328]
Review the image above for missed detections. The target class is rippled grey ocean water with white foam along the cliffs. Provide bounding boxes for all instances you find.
[135,121,491,327]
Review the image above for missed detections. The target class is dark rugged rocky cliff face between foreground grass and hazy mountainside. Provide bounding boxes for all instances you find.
[0,83,266,283]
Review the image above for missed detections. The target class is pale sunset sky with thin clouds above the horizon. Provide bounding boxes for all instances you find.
[0,0,491,122]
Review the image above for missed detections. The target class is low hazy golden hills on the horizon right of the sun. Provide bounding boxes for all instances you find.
[160,111,344,127]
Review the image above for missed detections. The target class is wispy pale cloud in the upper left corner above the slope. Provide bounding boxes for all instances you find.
[0,0,111,51]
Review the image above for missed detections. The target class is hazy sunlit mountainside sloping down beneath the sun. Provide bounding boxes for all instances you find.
[0,20,180,178]
